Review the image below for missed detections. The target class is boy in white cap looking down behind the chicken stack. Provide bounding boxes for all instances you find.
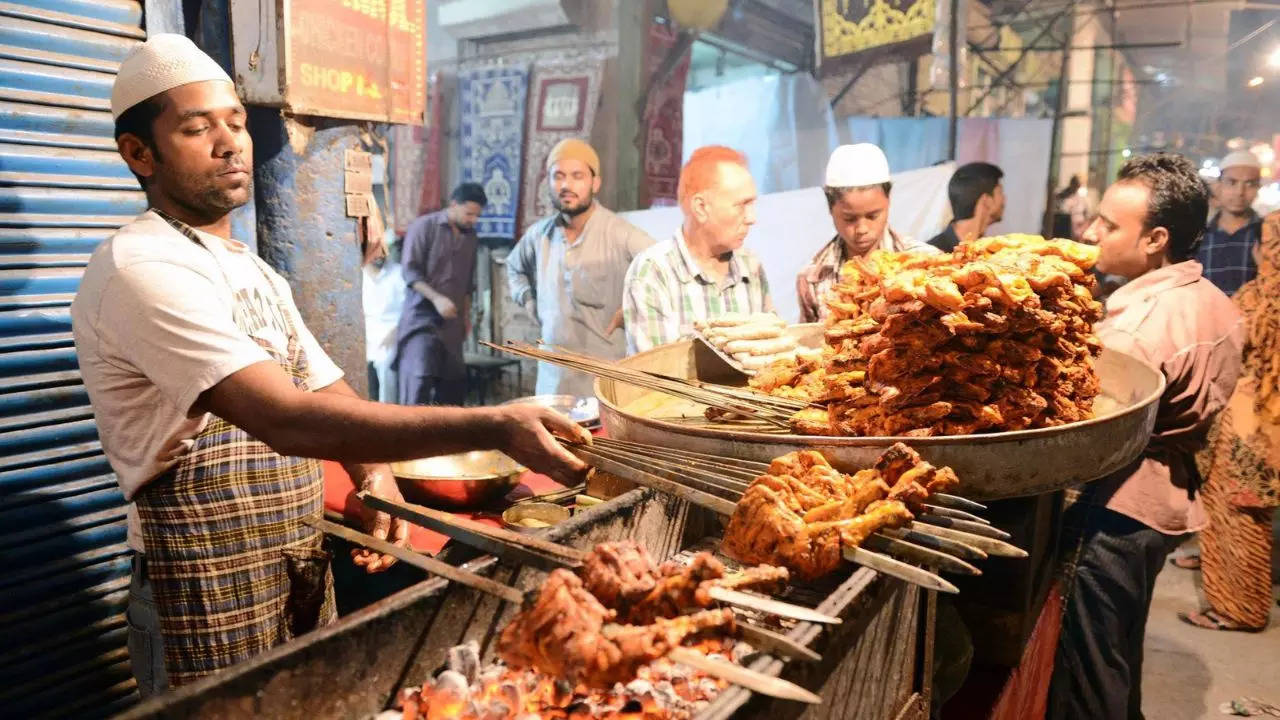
[796,142,937,323]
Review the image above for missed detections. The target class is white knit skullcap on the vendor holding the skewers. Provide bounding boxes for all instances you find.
[111,33,232,119]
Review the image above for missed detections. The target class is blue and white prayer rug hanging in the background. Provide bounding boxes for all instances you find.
[458,65,529,240]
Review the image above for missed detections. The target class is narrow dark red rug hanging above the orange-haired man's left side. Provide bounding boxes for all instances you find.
[644,26,689,206]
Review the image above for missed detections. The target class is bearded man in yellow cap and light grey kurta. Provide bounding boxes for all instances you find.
[507,138,653,396]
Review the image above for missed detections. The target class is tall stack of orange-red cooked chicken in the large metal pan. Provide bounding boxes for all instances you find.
[751,236,1102,437]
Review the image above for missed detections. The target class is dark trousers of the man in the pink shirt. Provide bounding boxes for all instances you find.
[1046,502,1187,720]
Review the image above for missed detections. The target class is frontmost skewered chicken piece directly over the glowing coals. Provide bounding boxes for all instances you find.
[498,569,735,688]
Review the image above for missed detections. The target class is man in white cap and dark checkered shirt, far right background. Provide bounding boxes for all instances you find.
[1196,150,1262,295]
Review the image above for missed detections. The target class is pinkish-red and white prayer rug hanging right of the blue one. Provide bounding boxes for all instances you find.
[520,58,604,228]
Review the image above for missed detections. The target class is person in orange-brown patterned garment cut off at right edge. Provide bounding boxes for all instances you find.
[1178,213,1280,632]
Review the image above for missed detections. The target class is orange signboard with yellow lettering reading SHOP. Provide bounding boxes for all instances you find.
[283,0,426,126]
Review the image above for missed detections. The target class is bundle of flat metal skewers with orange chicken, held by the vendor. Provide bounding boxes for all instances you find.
[568,438,1027,592]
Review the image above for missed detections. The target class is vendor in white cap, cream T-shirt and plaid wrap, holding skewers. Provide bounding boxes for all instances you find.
[72,35,585,696]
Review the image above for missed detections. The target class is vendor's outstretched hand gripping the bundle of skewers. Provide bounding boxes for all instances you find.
[493,405,591,486]
